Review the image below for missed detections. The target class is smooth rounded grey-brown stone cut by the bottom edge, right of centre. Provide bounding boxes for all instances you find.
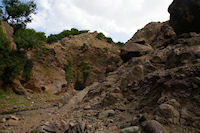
[142,120,166,133]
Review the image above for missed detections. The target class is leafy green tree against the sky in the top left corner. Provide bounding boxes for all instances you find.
[1,0,36,29]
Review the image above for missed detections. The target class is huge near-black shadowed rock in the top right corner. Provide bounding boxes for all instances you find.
[168,0,200,34]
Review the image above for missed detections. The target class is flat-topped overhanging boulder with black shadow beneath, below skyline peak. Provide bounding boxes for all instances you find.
[120,42,153,62]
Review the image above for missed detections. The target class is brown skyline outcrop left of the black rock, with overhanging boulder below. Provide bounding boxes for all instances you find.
[120,22,176,62]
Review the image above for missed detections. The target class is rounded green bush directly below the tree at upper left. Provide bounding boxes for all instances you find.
[14,29,46,49]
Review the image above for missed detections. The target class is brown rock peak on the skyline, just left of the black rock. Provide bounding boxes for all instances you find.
[127,21,176,48]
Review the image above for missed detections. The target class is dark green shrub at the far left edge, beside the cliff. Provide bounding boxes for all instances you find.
[0,23,25,84]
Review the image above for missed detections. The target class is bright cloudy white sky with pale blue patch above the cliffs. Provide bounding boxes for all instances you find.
[28,0,173,42]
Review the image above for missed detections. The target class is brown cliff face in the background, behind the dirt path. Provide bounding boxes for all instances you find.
[24,32,122,93]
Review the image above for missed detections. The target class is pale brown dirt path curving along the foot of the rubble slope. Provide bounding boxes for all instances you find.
[0,88,88,133]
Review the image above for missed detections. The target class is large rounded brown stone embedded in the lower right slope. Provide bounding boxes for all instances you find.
[159,103,180,124]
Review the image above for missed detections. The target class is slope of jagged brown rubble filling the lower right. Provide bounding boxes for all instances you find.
[34,23,200,133]
